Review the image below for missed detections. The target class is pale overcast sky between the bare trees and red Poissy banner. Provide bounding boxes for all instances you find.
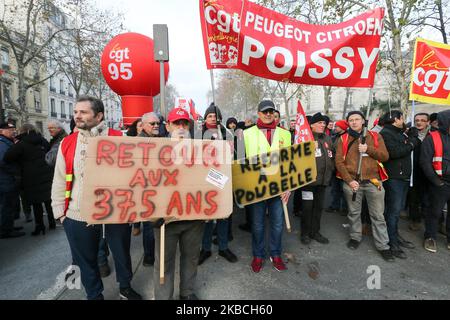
[96,0,211,115]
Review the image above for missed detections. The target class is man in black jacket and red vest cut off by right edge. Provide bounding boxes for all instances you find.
[420,110,450,252]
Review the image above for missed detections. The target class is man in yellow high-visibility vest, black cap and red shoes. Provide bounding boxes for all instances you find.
[244,100,291,273]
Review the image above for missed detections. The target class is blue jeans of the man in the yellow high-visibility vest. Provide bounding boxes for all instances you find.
[248,197,284,259]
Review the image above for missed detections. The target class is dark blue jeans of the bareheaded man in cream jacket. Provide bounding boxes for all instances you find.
[63,218,133,300]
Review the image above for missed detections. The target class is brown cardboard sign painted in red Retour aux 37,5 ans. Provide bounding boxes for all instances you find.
[81,137,233,224]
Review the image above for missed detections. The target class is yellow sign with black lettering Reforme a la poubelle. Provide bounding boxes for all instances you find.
[233,141,317,206]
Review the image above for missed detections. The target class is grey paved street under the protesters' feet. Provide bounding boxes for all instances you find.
[0,200,450,300]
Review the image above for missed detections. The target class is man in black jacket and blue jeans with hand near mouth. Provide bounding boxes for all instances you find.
[380,110,420,259]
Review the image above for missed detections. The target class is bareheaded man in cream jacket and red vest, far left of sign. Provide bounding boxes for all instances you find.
[52,96,142,300]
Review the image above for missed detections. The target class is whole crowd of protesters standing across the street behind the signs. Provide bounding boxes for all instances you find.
[0,97,450,300]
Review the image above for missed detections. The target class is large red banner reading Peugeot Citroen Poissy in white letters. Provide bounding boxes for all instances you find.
[200,0,384,87]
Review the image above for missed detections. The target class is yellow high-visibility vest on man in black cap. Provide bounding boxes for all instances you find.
[244,126,291,158]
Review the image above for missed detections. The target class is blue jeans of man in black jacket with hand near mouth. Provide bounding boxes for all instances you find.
[383,179,409,246]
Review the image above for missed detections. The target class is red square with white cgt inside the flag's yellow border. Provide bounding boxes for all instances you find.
[413,43,450,99]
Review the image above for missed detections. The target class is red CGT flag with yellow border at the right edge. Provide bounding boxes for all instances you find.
[409,38,450,105]
